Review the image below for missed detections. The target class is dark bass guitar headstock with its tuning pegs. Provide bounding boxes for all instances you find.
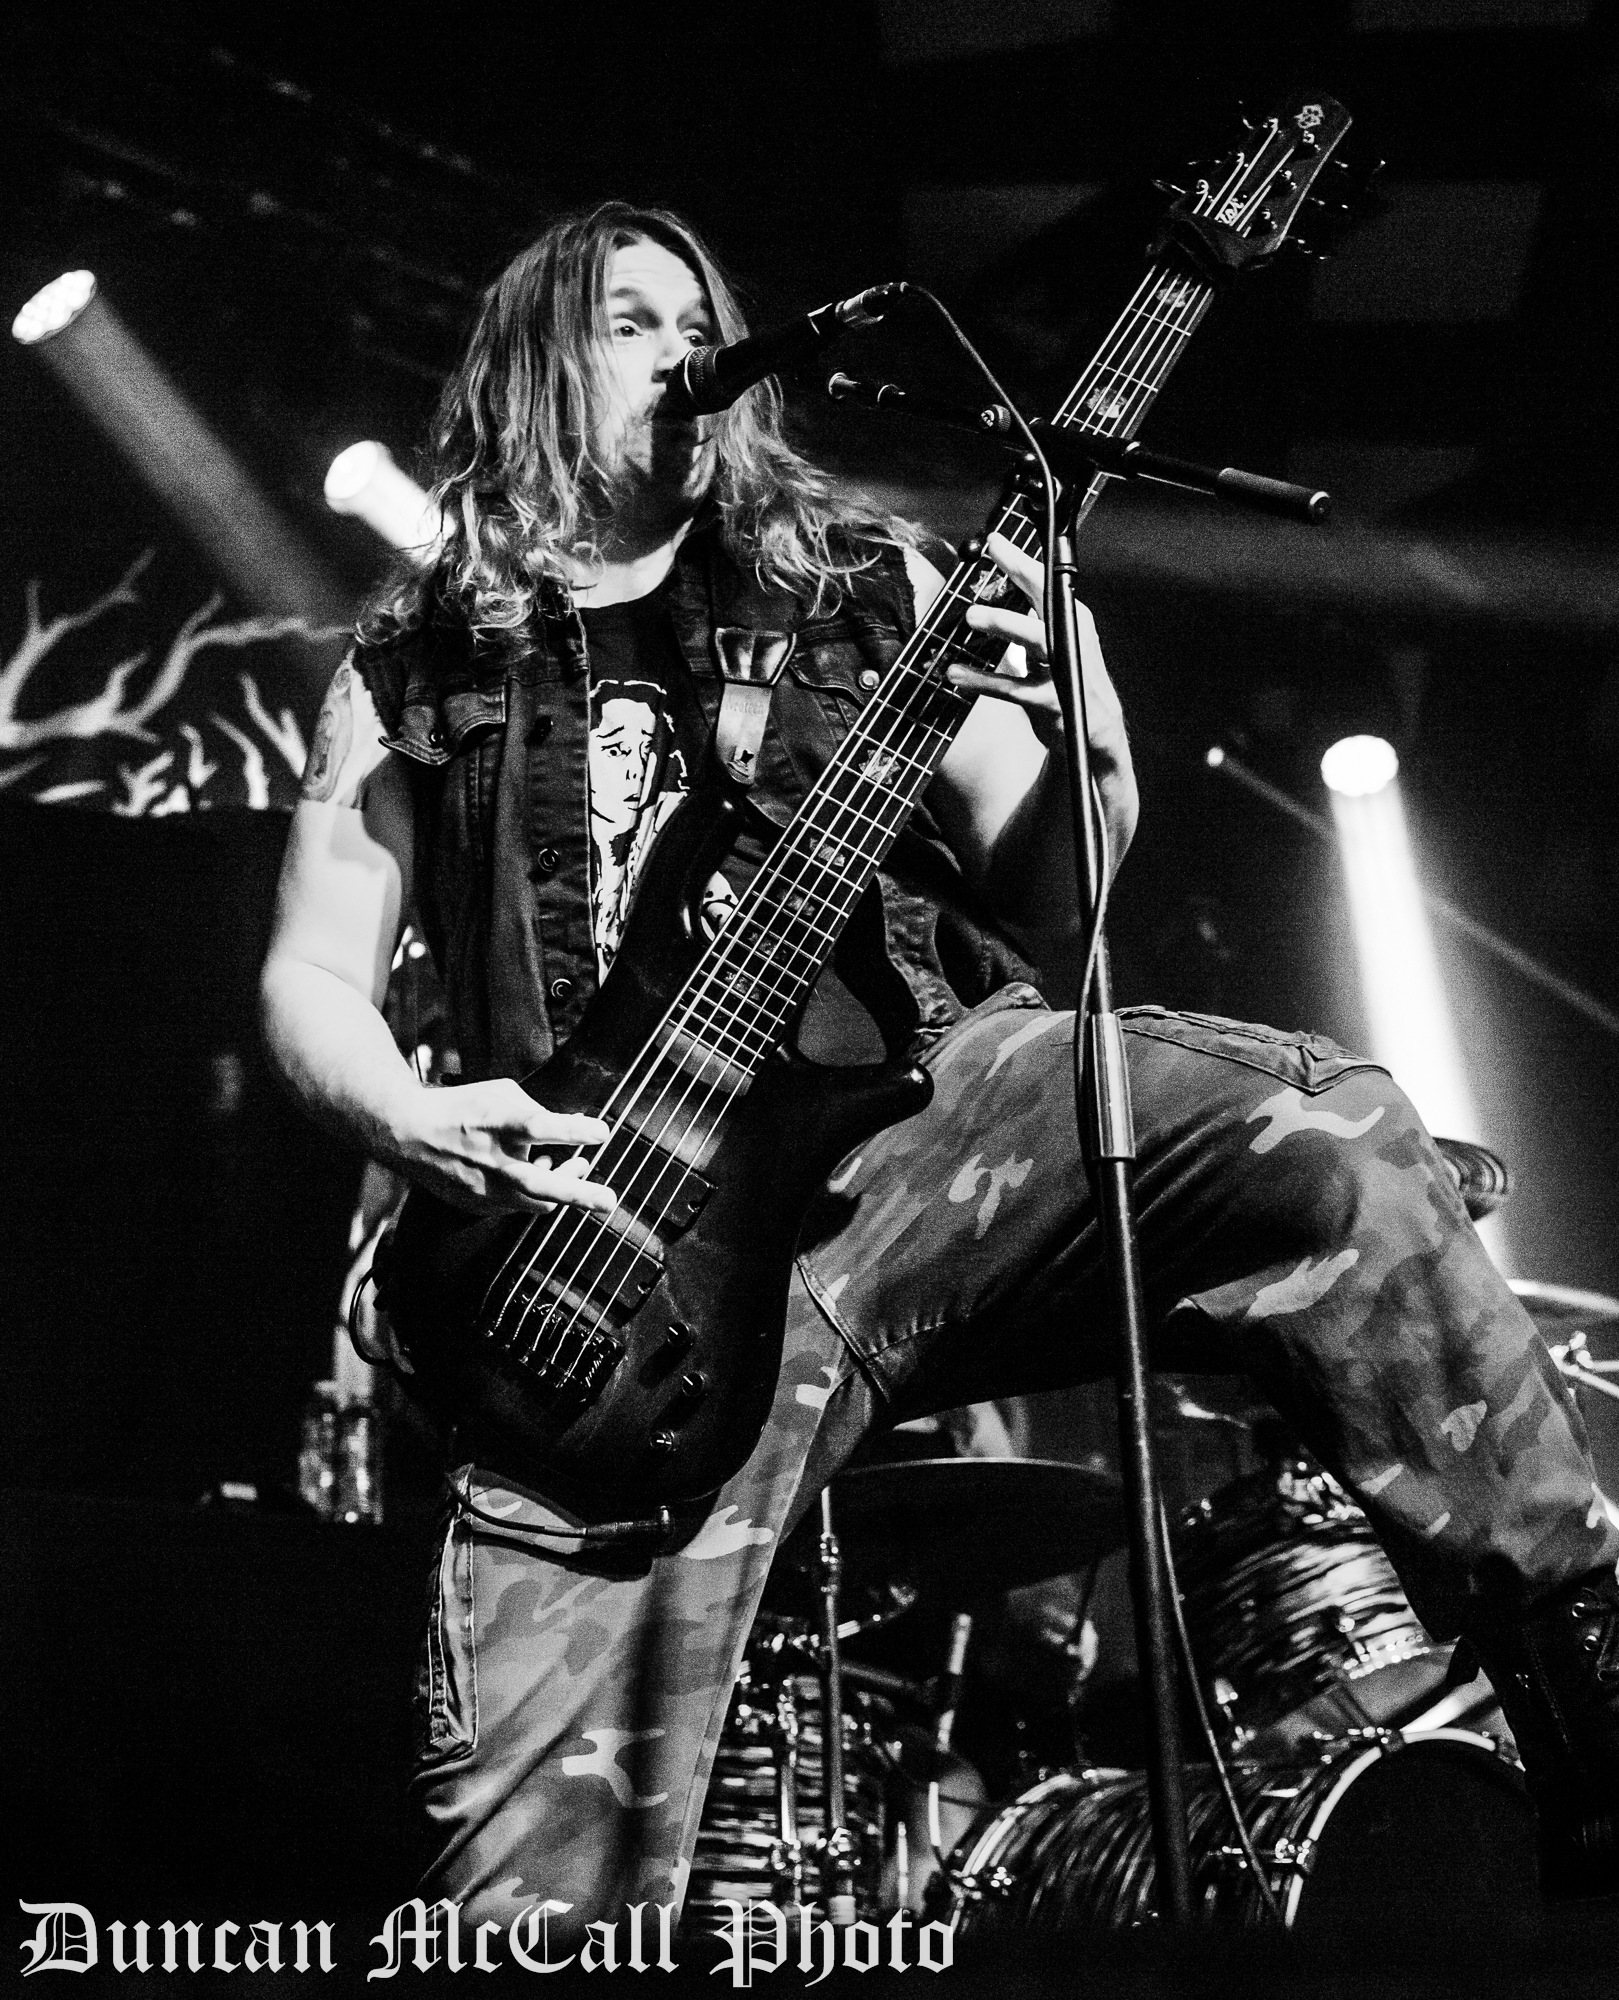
[1153,92,1349,284]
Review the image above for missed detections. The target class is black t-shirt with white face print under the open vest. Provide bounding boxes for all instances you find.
[580,588,708,978]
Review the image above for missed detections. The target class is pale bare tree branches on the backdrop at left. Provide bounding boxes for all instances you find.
[0,548,344,816]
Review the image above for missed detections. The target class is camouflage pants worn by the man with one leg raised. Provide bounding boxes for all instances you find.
[414,990,1619,1926]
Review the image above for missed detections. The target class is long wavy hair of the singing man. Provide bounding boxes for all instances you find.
[360,202,919,642]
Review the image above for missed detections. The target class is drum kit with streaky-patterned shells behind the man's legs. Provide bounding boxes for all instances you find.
[688,1160,1619,1936]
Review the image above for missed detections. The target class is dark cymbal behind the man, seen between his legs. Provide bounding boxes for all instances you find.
[766,1458,1125,1604]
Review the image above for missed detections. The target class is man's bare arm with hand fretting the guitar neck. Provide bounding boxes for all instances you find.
[907,536,1137,982]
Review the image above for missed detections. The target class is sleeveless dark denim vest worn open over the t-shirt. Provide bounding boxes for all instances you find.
[354,530,1031,1080]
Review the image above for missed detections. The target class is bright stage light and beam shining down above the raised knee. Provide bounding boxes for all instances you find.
[1321,736,1505,1262]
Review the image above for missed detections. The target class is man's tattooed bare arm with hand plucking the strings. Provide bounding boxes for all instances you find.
[260,662,614,1210]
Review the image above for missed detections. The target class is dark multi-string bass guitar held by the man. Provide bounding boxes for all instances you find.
[378,98,1349,1512]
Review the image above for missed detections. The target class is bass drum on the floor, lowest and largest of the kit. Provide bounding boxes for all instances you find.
[949,1730,1537,1936]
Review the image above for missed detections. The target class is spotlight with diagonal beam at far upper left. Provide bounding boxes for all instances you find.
[12,270,354,652]
